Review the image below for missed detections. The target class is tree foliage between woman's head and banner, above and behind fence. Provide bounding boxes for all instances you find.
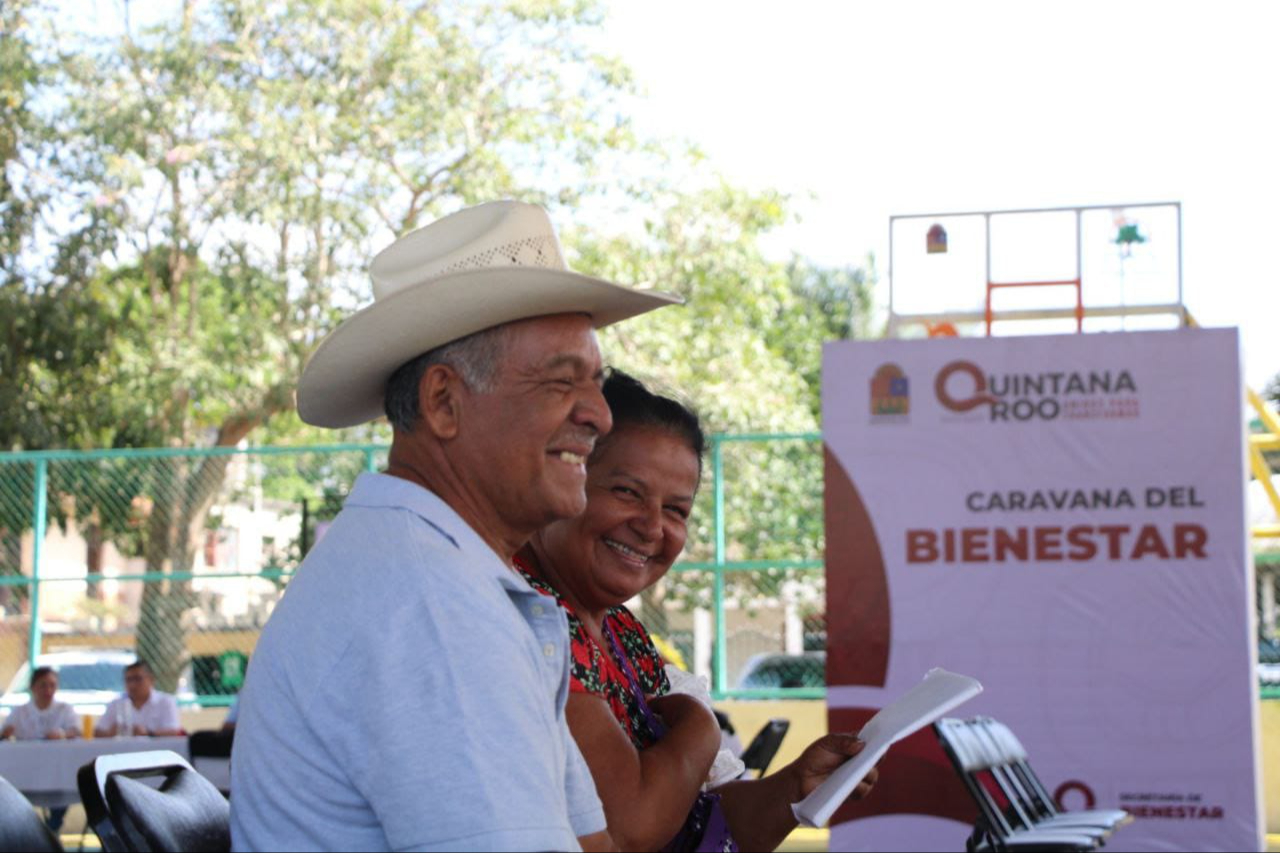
[575,184,874,605]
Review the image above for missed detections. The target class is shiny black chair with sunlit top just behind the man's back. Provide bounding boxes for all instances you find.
[76,751,232,853]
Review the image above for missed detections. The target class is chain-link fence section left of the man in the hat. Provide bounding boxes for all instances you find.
[0,446,387,706]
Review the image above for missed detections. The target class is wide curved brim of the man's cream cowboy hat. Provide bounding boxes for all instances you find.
[298,266,682,429]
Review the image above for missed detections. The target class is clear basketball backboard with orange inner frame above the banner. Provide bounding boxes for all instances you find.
[888,202,1185,337]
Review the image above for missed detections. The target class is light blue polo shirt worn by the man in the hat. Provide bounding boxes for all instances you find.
[232,474,605,850]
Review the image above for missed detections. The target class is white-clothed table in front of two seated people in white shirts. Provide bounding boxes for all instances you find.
[0,738,230,807]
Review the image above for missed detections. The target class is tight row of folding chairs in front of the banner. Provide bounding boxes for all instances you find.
[933,717,1133,853]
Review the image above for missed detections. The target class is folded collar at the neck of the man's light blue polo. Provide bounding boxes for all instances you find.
[343,471,540,594]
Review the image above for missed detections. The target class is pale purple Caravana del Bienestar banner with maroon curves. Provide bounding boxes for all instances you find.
[823,329,1262,850]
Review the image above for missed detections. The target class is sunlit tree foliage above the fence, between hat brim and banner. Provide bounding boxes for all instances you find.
[575,184,817,432]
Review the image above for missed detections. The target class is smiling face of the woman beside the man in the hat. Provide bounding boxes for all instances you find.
[541,427,699,608]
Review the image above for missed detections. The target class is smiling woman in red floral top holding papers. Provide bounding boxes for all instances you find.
[516,371,874,850]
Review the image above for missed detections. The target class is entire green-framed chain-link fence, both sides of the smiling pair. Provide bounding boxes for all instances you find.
[0,435,824,707]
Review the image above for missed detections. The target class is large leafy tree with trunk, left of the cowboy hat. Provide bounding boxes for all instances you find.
[15,0,660,686]
